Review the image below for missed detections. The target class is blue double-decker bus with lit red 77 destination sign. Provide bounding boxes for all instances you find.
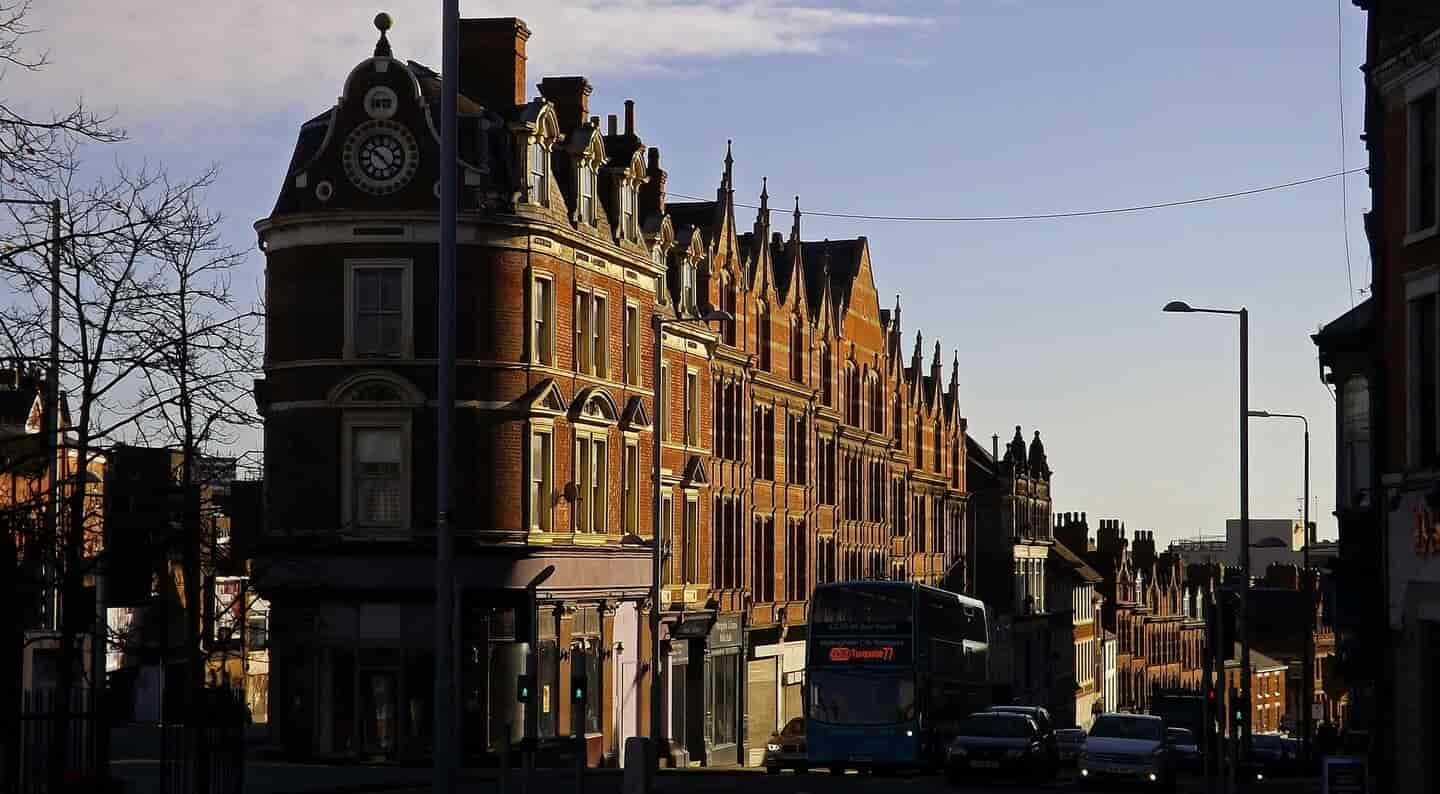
[805,582,989,772]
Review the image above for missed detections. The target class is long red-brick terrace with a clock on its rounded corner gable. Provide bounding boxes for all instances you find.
[255,13,972,765]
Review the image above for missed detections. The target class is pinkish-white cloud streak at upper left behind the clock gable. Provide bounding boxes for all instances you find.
[0,0,920,125]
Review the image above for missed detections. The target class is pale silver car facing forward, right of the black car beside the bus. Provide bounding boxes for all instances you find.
[1080,713,1175,788]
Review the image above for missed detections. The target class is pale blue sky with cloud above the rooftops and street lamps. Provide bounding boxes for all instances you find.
[0,0,1369,542]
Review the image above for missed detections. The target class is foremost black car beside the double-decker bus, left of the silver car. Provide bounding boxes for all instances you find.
[945,712,1056,782]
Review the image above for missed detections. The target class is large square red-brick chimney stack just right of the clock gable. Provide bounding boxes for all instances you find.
[459,17,530,111]
